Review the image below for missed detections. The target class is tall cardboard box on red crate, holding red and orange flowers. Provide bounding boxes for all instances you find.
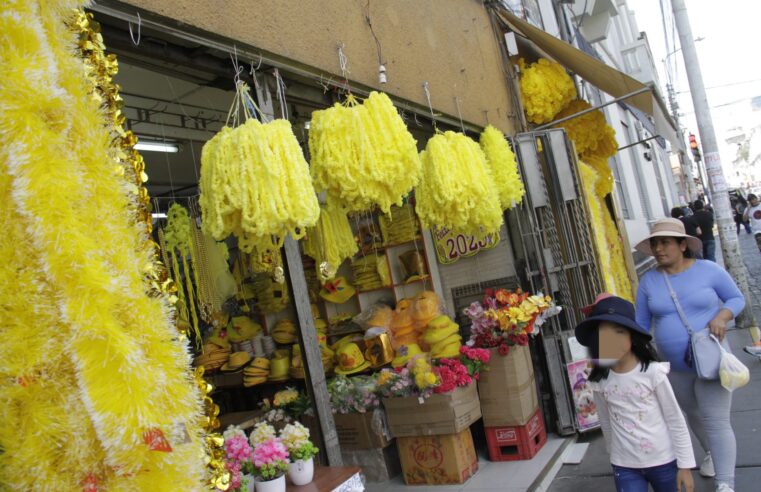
[478,345,539,427]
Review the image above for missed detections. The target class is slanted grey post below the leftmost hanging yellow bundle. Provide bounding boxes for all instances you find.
[284,235,343,466]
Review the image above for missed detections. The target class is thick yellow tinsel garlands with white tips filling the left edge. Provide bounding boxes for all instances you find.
[0,0,205,491]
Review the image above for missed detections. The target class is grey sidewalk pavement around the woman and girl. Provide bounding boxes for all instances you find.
[548,232,761,492]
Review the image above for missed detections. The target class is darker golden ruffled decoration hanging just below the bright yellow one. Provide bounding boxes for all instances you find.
[556,99,618,159]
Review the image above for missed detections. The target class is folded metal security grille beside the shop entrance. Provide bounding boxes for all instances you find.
[513,130,602,434]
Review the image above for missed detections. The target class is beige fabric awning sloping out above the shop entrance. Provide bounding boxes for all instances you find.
[497,10,684,148]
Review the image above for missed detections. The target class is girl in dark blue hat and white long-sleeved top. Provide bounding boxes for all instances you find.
[575,296,695,492]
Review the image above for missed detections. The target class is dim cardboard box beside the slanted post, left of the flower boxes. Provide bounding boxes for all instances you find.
[333,408,393,449]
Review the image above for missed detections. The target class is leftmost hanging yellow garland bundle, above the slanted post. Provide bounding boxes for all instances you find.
[199,118,320,252]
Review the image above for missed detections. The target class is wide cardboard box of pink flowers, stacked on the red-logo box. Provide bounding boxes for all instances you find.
[383,384,481,437]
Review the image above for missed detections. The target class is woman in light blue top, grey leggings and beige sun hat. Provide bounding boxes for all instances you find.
[636,219,745,492]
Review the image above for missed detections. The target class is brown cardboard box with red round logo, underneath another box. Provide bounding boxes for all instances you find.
[396,428,478,485]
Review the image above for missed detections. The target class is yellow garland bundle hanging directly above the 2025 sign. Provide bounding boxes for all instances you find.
[415,131,502,237]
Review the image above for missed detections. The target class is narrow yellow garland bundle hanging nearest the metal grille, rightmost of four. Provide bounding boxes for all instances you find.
[480,125,526,210]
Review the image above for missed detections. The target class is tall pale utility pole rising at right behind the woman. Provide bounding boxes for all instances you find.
[671,0,759,340]
